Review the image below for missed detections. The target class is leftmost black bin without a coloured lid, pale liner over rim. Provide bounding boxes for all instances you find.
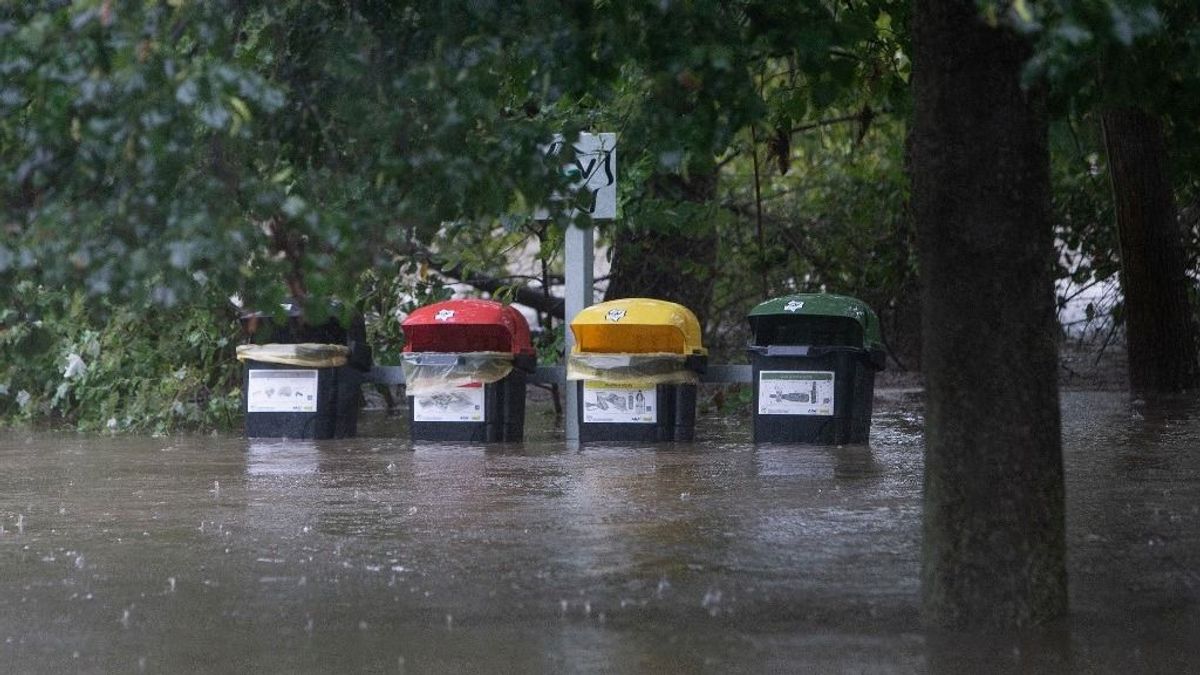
[238,303,371,438]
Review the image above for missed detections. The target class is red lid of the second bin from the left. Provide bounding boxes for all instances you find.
[400,299,534,354]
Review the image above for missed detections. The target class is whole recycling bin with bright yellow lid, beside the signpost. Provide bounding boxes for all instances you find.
[566,298,708,442]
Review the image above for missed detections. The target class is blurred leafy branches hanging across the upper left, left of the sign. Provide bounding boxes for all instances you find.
[0,1,580,306]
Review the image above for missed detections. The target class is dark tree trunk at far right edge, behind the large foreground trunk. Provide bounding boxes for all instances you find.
[1102,108,1198,392]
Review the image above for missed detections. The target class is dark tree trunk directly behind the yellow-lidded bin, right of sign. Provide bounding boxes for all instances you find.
[605,173,718,327]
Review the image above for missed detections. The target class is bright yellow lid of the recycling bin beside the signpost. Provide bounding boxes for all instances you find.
[571,298,708,354]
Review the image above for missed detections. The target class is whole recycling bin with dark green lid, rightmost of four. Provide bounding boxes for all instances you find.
[748,293,884,444]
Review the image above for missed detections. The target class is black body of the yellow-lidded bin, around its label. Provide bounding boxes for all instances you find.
[576,382,696,443]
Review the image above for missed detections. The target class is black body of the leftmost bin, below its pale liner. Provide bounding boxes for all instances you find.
[241,360,362,438]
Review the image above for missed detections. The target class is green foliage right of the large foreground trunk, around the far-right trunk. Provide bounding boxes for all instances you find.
[998,0,1200,336]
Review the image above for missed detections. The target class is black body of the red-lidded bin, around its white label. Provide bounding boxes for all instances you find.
[408,368,527,443]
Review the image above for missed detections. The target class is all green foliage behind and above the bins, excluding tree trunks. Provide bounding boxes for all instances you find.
[11,0,1171,430]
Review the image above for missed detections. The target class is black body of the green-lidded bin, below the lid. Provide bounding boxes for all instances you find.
[750,346,876,446]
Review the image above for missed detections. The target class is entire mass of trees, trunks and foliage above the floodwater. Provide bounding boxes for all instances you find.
[0,0,1200,626]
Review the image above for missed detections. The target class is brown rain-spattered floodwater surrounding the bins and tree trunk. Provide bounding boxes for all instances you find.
[0,392,1200,673]
